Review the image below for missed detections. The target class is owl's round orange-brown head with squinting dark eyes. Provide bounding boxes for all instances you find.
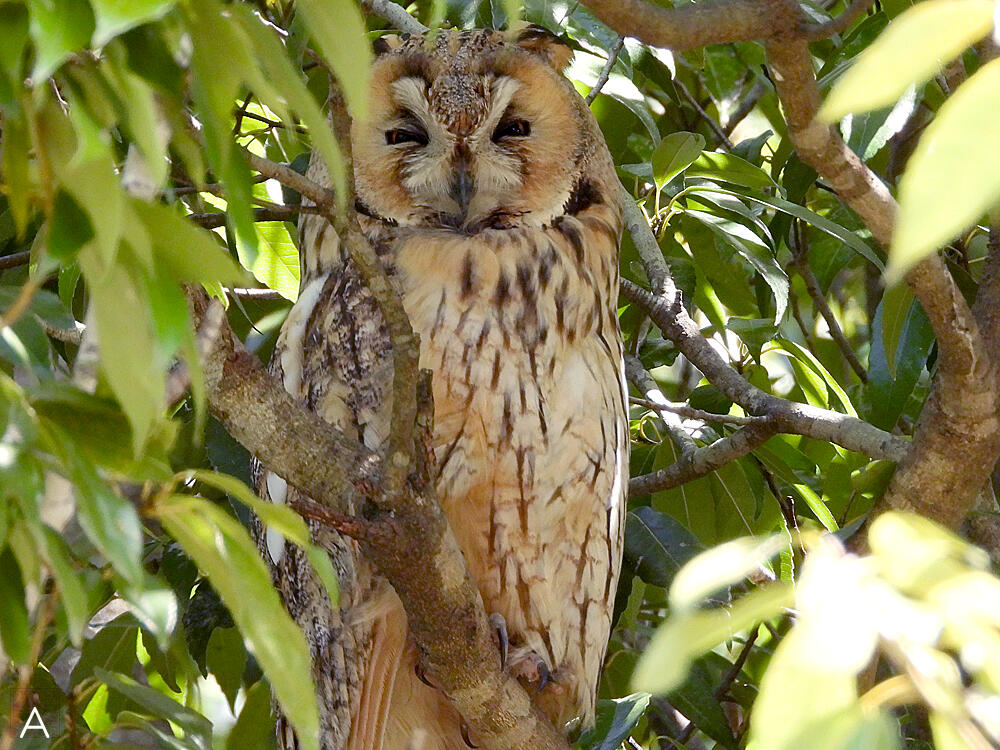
[352,27,593,233]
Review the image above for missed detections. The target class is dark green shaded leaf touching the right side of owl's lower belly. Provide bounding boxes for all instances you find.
[625,506,703,588]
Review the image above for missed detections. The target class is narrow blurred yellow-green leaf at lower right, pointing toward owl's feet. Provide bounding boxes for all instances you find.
[632,583,793,694]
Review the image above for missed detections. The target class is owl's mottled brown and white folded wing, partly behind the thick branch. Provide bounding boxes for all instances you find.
[255,194,407,750]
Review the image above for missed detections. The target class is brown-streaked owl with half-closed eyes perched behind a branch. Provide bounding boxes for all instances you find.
[258,27,628,750]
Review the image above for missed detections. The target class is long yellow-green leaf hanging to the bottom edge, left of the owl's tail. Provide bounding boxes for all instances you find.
[155,497,319,750]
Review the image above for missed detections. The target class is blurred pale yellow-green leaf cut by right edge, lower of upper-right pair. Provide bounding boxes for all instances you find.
[886,57,1000,284]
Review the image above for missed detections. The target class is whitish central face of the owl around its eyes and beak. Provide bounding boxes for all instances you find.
[382,76,532,229]
